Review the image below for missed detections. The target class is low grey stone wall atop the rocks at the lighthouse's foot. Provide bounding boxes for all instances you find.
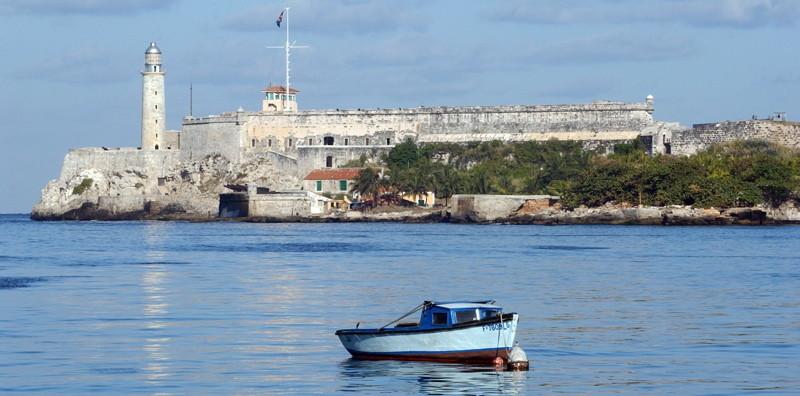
[60,148,179,183]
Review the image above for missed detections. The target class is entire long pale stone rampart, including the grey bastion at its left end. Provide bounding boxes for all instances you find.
[180,101,654,160]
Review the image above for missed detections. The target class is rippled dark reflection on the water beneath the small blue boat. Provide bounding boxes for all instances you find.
[339,359,528,395]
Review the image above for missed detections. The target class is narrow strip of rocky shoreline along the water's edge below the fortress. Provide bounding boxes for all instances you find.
[31,203,800,226]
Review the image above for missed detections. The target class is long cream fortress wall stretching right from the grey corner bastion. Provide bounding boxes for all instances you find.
[238,102,654,152]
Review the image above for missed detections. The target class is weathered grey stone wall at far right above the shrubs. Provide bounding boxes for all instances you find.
[672,120,800,155]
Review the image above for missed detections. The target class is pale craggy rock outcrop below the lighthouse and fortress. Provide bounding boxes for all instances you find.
[31,156,300,220]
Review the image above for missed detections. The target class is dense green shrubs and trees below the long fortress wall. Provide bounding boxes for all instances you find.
[364,140,800,207]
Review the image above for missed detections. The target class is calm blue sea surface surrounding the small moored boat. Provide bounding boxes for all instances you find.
[0,215,800,395]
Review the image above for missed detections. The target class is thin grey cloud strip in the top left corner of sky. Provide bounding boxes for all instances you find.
[0,0,179,15]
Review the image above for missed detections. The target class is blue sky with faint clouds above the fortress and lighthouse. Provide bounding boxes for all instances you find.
[0,0,800,213]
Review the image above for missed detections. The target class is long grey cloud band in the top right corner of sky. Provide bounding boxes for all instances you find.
[491,0,800,28]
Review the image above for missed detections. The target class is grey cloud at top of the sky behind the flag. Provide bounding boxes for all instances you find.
[220,0,427,35]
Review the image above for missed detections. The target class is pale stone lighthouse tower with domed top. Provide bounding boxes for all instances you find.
[142,43,167,150]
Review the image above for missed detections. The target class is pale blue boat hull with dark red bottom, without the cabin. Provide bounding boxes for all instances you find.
[336,313,519,362]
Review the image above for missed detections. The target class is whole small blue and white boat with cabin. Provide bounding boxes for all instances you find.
[336,300,519,363]
